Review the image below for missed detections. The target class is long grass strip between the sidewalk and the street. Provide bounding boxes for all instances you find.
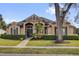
[0,48,79,55]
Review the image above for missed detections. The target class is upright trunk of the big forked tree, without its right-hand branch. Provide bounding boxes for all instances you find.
[54,3,63,43]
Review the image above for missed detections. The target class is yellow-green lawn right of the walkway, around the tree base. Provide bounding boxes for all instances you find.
[27,40,79,46]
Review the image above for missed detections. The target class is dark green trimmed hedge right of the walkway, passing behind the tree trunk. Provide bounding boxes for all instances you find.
[33,35,79,40]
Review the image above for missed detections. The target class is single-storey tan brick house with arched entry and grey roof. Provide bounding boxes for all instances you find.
[6,14,76,37]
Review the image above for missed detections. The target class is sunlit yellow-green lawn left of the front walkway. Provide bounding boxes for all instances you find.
[0,38,21,46]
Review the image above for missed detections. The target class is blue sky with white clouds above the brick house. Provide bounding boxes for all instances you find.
[0,3,78,27]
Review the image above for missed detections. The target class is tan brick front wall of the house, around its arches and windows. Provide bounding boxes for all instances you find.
[7,19,75,35]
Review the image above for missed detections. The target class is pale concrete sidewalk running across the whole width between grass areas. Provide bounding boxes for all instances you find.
[0,46,79,49]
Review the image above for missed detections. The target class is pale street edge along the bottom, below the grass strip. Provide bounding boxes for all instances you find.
[0,53,75,56]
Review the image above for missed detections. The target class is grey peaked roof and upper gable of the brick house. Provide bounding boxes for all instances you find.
[9,14,76,26]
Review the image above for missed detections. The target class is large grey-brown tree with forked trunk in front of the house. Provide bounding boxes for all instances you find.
[50,3,72,43]
